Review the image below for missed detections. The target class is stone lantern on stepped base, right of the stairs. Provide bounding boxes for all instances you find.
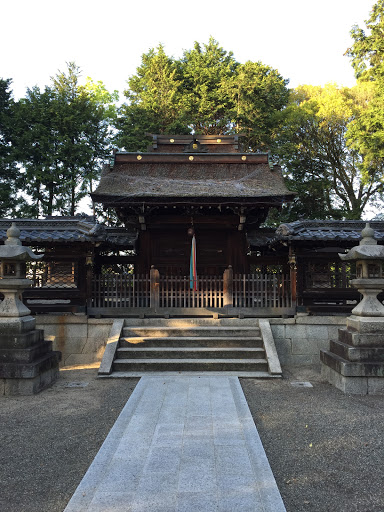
[320,224,384,395]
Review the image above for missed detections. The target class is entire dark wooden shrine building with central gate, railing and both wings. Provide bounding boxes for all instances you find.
[0,135,384,316]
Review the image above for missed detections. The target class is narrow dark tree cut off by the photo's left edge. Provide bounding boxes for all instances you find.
[0,79,18,217]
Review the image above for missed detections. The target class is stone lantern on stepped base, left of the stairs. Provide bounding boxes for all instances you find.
[0,223,60,395]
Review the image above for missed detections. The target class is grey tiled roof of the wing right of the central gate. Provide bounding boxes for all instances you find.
[276,220,384,242]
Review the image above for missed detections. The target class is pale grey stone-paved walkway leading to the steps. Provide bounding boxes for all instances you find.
[65,376,285,512]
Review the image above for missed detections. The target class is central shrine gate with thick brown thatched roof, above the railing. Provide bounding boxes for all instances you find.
[92,135,293,276]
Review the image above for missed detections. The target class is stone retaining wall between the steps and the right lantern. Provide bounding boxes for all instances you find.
[270,316,346,366]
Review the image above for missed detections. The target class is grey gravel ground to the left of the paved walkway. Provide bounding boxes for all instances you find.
[0,369,138,512]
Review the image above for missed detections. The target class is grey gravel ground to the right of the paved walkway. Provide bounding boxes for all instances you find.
[240,368,384,512]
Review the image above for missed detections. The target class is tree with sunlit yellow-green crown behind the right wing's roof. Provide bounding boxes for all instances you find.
[276,84,383,220]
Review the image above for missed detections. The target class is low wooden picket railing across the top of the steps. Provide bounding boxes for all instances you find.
[88,267,294,314]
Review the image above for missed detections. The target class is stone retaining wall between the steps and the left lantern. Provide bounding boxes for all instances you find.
[36,315,113,366]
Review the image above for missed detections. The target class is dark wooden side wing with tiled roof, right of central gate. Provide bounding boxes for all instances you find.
[269,220,384,314]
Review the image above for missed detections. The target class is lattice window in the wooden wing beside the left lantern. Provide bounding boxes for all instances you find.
[27,261,78,288]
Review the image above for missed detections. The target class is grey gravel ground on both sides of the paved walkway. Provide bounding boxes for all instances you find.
[0,367,384,512]
